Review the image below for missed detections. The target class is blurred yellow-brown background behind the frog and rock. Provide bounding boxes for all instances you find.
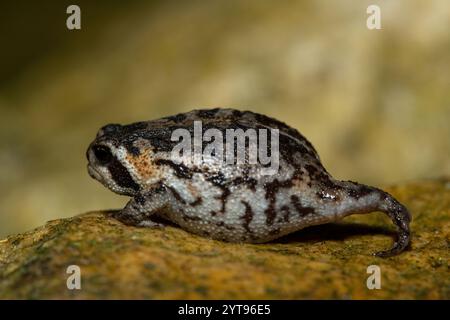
[0,0,450,237]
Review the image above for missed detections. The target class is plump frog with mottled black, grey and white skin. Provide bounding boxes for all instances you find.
[87,109,411,257]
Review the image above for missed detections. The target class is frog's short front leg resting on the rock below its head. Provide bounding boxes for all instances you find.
[114,184,168,228]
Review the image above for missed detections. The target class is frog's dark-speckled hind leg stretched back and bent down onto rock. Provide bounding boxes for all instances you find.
[339,181,411,257]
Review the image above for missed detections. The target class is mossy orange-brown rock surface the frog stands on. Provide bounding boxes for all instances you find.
[0,179,450,299]
